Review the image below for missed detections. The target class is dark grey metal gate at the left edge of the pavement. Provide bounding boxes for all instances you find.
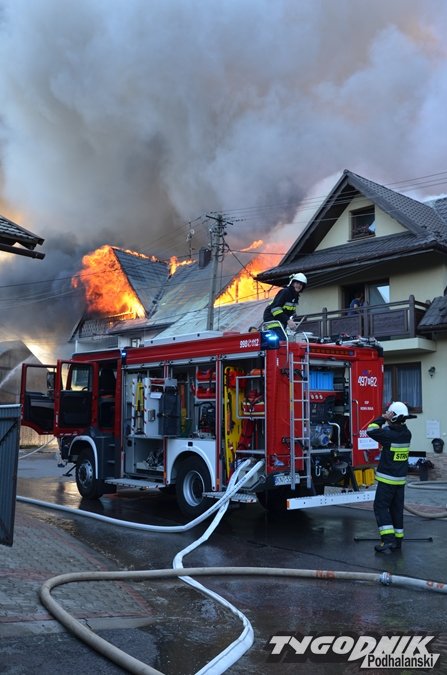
[0,405,20,546]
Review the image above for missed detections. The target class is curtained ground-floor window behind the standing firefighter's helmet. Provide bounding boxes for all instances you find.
[383,363,422,413]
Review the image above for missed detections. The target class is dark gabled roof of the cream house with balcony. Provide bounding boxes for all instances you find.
[257,170,447,285]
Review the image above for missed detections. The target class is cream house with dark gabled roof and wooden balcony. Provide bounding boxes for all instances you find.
[258,170,447,460]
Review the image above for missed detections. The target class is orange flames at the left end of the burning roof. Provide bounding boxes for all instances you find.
[71,244,146,319]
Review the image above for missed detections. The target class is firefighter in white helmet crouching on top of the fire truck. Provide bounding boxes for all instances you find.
[263,272,307,340]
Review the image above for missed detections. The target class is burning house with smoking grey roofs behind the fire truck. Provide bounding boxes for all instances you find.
[70,247,268,351]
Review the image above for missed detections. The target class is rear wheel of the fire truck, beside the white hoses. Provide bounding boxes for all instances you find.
[175,457,214,518]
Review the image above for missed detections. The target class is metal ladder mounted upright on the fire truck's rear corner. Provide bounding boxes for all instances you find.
[288,340,312,490]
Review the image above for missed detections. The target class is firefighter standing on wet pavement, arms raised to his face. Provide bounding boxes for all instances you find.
[366,401,414,554]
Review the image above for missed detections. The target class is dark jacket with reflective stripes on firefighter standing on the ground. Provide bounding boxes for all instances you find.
[366,417,411,485]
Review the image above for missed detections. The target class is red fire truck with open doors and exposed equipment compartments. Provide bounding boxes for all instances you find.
[21,331,383,517]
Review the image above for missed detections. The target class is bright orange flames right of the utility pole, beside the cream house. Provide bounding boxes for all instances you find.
[214,248,284,307]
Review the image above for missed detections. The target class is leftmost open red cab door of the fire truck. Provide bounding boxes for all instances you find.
[20,363,56,434]
